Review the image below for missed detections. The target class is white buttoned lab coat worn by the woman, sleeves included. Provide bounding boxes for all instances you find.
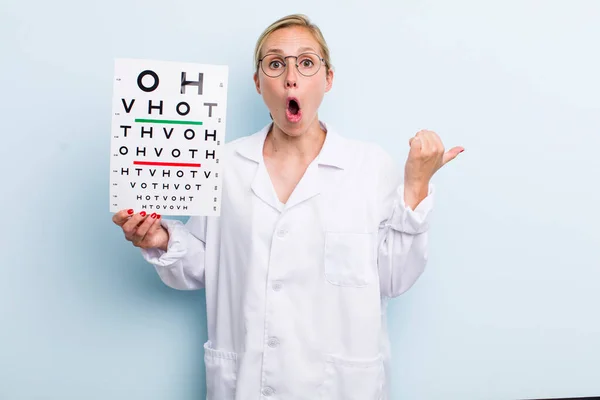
[142,122,433,400]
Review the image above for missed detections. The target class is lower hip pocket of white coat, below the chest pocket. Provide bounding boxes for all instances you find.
[319,356,384,400]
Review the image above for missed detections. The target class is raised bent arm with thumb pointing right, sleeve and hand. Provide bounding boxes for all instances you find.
[377,130,464,297]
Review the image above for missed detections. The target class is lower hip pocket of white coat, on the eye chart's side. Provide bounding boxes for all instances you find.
[204,341,237,400]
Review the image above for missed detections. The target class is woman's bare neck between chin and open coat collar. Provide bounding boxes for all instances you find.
[264,118,325,162]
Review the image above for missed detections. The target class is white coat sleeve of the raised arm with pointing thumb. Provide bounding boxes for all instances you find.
[377,148,434,298]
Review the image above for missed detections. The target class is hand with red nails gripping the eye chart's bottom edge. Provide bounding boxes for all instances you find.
[112,209,169,251]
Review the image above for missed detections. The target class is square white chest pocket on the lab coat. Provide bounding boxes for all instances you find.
[324,232,377,287]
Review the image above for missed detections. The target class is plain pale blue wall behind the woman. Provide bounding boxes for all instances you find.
[0,0,600,400]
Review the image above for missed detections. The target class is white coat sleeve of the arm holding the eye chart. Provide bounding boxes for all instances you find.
[141,217,207,290]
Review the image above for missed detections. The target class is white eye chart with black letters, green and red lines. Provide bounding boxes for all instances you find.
[110,59,228,216]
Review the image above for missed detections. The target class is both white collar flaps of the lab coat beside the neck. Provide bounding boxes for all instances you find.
[237,121,349,169]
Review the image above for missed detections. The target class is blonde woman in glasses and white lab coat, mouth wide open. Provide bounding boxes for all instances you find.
[113,15,462,400]
